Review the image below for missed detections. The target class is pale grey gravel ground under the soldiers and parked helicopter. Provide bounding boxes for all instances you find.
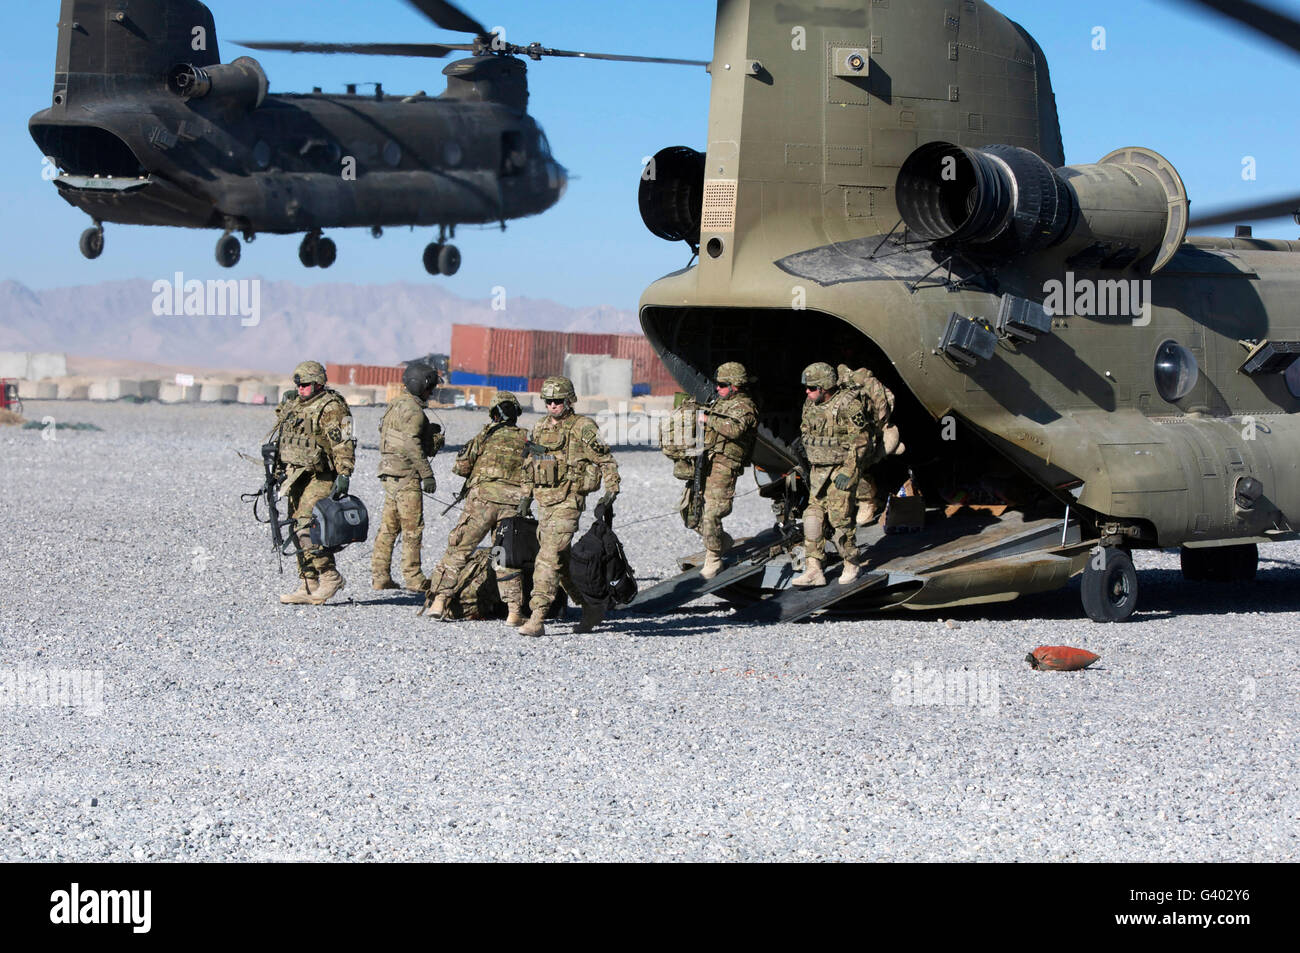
[0,402,1300,861]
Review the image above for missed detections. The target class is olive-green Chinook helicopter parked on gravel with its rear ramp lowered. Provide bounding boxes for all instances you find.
[624,0,1300,621]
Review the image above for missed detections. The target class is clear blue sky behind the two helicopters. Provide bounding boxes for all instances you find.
[0,0,1300,308]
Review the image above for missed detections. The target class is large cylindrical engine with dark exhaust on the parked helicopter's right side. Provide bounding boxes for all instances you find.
[894,142,1187,272]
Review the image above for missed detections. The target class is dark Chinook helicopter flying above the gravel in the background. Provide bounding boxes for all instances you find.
[29,0,706,276]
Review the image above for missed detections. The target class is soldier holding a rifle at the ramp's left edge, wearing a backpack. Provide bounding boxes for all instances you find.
[697,361,758,579]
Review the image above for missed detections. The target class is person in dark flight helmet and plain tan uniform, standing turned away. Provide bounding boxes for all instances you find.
[371,361,446,592]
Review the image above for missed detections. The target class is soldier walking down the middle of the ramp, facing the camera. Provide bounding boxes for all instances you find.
[790,364,875,586]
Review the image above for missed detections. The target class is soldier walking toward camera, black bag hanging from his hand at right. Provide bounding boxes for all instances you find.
[519,377,619,636]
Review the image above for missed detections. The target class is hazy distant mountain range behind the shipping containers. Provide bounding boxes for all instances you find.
[0,280,641,371]
